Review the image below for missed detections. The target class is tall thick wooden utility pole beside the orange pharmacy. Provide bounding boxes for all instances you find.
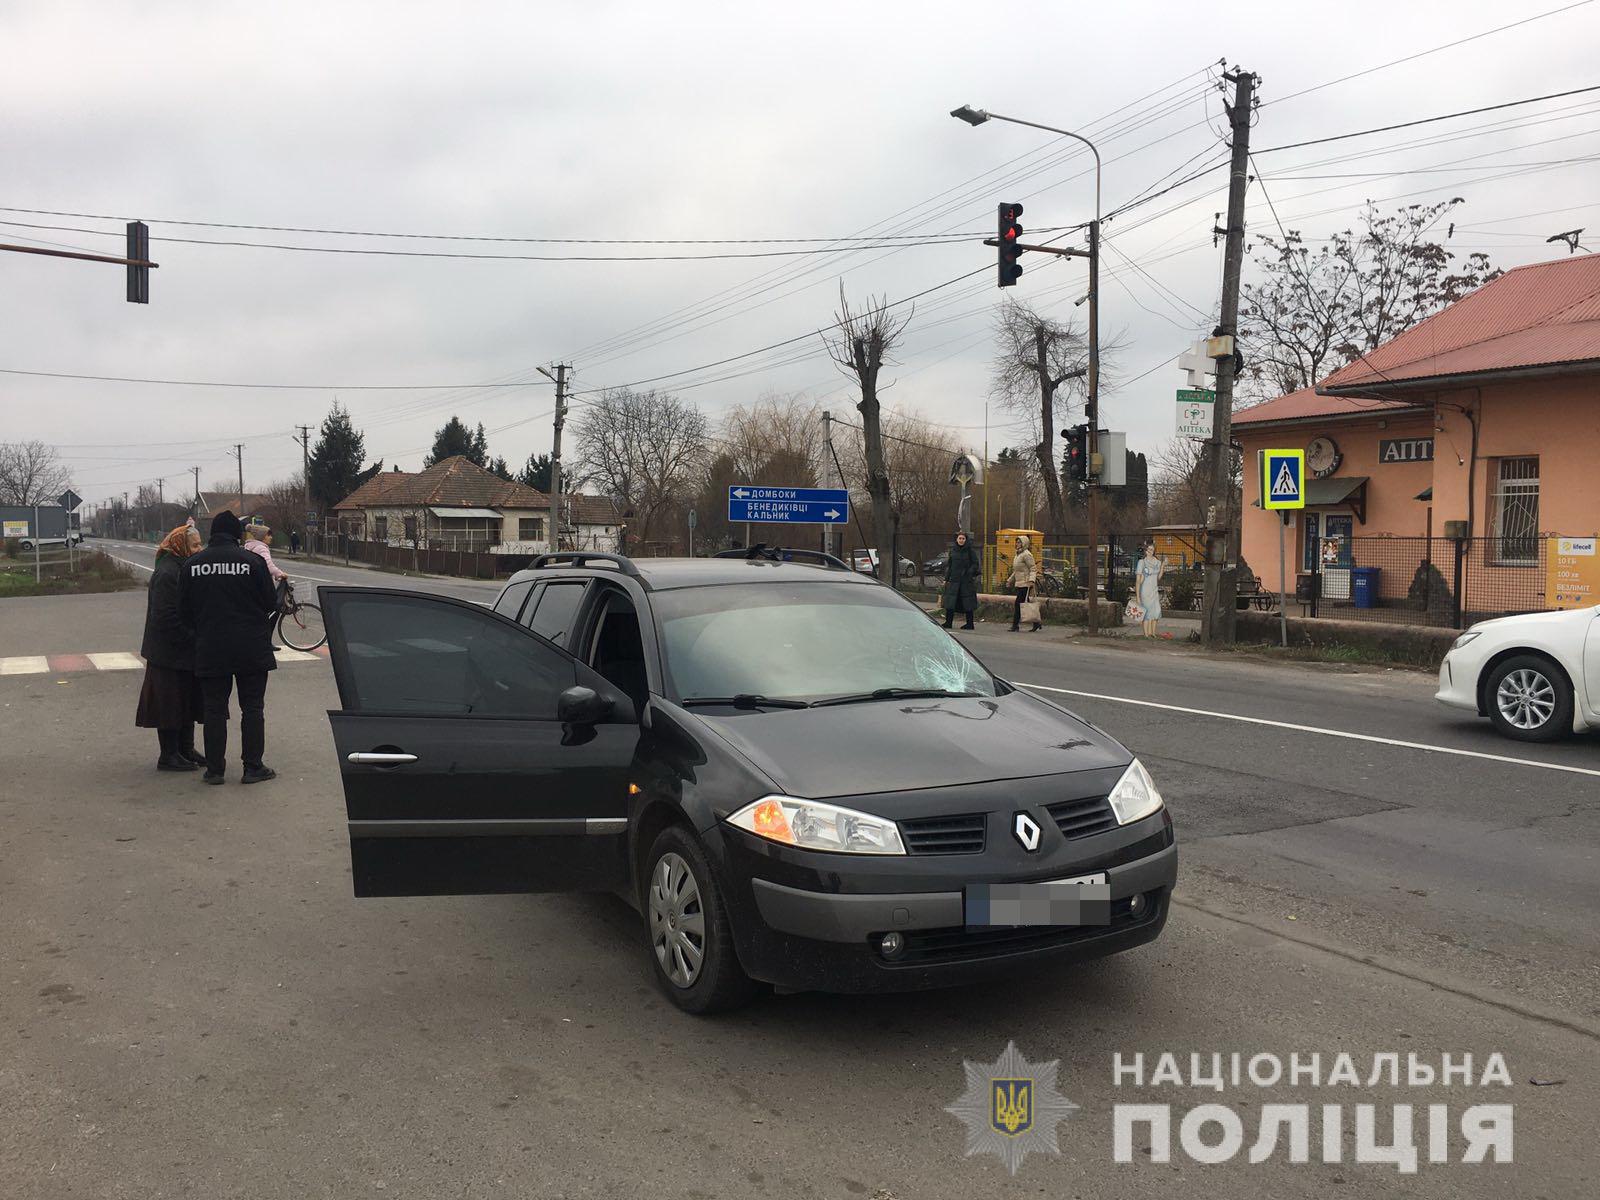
[1203,69,1256,646]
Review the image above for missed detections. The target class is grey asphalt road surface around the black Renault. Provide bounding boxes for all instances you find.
[0,579,1600,1200]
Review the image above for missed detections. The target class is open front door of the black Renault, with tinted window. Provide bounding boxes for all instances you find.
[320,587,640,896]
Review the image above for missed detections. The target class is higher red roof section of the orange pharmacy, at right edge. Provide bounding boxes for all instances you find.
[1312,254,1600,392]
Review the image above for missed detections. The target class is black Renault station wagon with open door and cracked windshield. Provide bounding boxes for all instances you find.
[322,547,1178,1013]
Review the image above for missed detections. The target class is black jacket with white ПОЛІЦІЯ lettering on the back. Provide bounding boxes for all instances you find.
[182,534,278,677]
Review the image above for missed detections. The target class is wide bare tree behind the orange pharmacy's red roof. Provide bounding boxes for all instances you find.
[1240,197,1499,400]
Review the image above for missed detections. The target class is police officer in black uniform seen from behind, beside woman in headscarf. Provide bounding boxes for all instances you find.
[182,509,277,784]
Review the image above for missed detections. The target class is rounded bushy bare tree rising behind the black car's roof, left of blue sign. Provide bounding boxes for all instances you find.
[576,387,706,542]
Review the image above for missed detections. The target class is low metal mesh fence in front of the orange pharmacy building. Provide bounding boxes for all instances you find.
[1292,536,1568,629]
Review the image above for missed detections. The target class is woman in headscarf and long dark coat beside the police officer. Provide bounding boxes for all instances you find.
[134,525,205,771]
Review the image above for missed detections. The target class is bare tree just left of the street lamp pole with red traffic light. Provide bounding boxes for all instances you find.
[994,298,1106,536]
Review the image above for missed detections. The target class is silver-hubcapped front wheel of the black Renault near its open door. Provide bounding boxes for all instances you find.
[643,826,755,1013]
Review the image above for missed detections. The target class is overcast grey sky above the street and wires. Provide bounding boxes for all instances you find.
[0,0,1600,512]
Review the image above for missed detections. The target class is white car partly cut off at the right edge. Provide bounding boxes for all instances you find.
[1434,608,1600,742]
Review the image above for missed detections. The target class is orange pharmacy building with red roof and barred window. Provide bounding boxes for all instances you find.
[1234,254,1600,611]
